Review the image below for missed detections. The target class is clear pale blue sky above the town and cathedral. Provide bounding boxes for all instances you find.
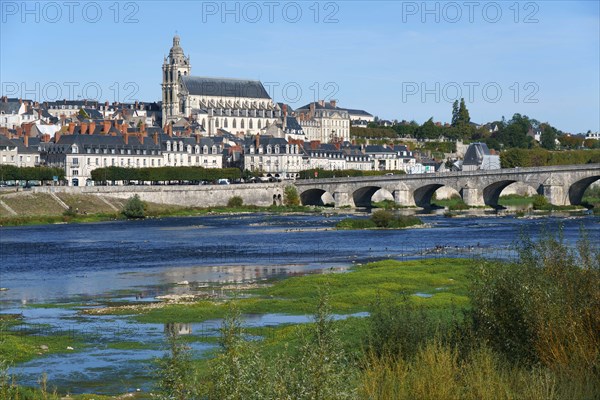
[0,0,600,133]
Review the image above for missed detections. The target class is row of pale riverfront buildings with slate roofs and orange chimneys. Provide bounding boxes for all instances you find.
[0,118,417,186]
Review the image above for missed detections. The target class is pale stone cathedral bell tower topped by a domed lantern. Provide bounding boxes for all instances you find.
[162,35,192,126]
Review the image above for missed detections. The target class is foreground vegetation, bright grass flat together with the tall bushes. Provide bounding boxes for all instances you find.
[0,233,600,400]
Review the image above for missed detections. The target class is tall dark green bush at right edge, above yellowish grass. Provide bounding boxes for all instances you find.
[472,230,600,370]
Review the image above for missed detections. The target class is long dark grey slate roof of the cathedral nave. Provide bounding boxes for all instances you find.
[181,76,271,99]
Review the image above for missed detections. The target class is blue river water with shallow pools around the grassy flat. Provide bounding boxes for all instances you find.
[0,214,600,394]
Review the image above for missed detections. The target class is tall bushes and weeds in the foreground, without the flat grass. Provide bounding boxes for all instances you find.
[151,228,600,400]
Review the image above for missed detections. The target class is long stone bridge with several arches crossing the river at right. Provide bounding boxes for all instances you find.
[295,164,600,207]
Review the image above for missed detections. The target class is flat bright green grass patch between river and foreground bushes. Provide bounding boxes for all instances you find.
[91,259,472,323]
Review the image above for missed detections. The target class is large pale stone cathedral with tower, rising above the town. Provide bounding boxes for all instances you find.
[162,35,282,136]
